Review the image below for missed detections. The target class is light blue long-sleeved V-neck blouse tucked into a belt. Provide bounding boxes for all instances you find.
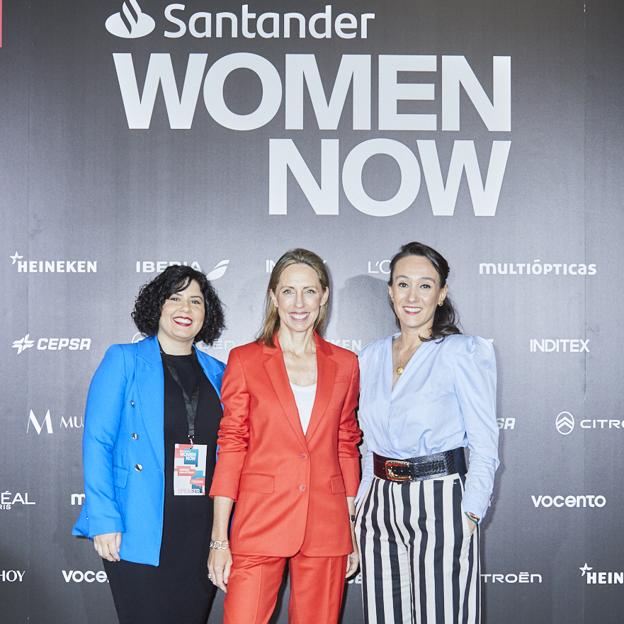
[357,334,499,518]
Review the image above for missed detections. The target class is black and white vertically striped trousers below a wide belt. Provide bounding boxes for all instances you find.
[356,474,481,624]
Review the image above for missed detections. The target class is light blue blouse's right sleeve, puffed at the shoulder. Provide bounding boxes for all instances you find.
[455,336,499,519]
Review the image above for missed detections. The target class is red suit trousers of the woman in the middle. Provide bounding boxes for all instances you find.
[223,553,347,624]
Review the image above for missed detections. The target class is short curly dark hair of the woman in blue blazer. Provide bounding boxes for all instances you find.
[132,265,225,345]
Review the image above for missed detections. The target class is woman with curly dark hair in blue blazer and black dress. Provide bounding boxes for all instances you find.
[73,266,224,624]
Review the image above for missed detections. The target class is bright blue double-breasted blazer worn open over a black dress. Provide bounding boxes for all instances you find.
[72,336,225,565]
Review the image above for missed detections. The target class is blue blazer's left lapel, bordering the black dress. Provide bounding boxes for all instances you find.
[135,336,165,469]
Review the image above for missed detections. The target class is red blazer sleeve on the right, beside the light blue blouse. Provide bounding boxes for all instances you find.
[338,355,362,496]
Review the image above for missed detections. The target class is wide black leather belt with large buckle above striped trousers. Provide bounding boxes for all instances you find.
[373,447,467,481]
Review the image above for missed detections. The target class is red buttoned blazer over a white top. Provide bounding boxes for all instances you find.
[210,335,361,557]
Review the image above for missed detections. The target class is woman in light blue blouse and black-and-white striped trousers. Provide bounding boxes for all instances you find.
[357,242,499,624]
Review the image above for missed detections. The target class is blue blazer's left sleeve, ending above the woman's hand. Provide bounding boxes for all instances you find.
[74,345,126,537]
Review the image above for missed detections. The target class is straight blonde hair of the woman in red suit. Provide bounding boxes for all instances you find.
[258,248,329,347]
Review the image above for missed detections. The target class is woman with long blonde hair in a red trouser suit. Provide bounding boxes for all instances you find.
[208,249,360,624]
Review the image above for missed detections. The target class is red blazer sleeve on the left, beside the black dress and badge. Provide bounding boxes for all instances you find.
[210,349,249,500]
